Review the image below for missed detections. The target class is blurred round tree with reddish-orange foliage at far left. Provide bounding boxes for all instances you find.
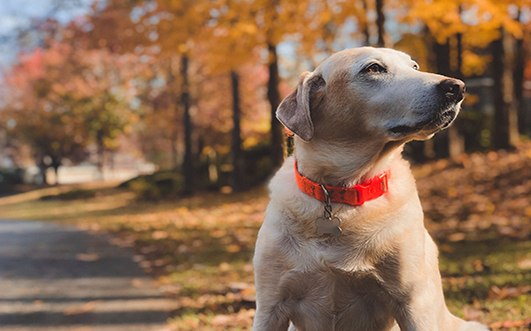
[4,37,141,183]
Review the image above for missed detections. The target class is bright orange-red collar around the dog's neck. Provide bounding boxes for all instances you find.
[295,161,389,206]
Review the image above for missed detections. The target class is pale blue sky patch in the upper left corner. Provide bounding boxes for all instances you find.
[0,0,94,74]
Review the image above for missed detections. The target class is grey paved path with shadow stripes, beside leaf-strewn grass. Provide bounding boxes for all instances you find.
[0,220,179,331]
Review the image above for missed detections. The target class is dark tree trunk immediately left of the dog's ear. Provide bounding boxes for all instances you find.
[267,43,284,169]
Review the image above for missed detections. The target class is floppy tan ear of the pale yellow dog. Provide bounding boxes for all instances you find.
[277,71,325,141]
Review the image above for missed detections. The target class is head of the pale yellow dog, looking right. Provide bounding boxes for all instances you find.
[277,47,465,143]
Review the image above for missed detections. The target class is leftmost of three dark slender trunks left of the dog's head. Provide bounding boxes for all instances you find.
[181,54,194,194]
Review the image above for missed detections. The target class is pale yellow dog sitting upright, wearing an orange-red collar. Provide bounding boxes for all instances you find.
[253,47,488,331]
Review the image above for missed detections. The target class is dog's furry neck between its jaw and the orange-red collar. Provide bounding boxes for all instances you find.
[295,137,403,187]
